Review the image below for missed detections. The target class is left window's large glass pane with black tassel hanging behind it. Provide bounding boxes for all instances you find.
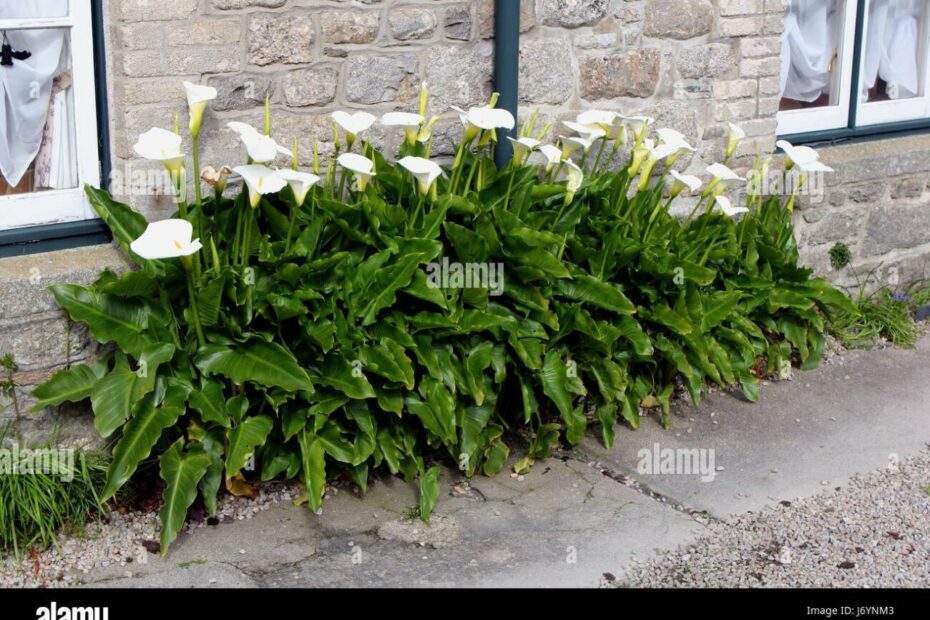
[0,28,78,195]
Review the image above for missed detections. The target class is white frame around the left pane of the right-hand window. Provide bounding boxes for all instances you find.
[776,0,858,136]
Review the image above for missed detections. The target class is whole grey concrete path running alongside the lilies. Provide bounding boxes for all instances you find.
[83,338,930,587]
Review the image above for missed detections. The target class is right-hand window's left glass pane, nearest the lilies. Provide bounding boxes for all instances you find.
[780,0,843,110]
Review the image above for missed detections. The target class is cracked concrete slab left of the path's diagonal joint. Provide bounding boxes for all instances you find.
[78,457,704,587]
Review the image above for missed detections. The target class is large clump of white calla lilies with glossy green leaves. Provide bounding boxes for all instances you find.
[35,85,851,552]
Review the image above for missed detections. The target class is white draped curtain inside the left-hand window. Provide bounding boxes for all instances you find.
[0,0,68,186]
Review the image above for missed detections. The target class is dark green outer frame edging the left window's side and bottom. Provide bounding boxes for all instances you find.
[0,0,112,258]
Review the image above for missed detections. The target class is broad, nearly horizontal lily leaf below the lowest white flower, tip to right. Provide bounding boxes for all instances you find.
[194,341,313,393]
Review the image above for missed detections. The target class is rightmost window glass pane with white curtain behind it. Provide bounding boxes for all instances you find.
[860,0,927,102]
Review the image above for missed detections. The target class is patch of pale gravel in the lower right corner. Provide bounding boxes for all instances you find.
[624,451,930,588]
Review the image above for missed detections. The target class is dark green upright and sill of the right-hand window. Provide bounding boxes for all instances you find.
[778,0,930,144]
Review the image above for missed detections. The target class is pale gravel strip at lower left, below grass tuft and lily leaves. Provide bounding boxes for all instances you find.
[0,482,302,588]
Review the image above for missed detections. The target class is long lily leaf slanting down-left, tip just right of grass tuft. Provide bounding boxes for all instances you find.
[101,395,184,501]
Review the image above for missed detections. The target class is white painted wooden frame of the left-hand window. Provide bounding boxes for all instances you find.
[0,0,100,231]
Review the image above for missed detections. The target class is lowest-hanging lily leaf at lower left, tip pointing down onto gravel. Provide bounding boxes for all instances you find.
[158,439,210,556]
